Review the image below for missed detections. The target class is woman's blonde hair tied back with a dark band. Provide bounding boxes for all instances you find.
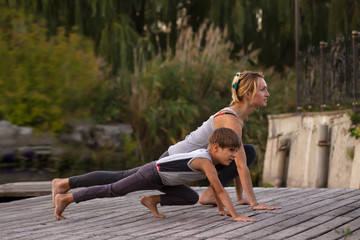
[230,71,264,105]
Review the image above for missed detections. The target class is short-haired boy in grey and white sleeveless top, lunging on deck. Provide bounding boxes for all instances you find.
[54,128,255,222]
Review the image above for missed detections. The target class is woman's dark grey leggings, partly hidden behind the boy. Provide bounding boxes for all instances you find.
[69,144,257,189]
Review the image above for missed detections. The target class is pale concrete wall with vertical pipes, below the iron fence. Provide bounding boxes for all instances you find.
[263,111,360,188]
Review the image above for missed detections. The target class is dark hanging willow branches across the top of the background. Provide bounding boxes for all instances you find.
[0,0,360,71]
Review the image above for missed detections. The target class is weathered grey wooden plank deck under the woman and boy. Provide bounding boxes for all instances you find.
[0,187,360,240]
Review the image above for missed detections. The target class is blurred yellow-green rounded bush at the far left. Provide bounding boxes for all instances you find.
[0,11,102,131]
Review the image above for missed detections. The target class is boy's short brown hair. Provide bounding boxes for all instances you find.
[209,127,241,148]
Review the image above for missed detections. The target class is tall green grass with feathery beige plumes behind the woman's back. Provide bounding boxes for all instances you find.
[121,24,235,161]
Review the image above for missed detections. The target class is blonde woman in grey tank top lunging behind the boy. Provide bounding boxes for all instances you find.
[52,71,279,210]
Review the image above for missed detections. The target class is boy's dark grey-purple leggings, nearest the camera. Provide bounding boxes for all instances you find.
[73,162,199,206]
